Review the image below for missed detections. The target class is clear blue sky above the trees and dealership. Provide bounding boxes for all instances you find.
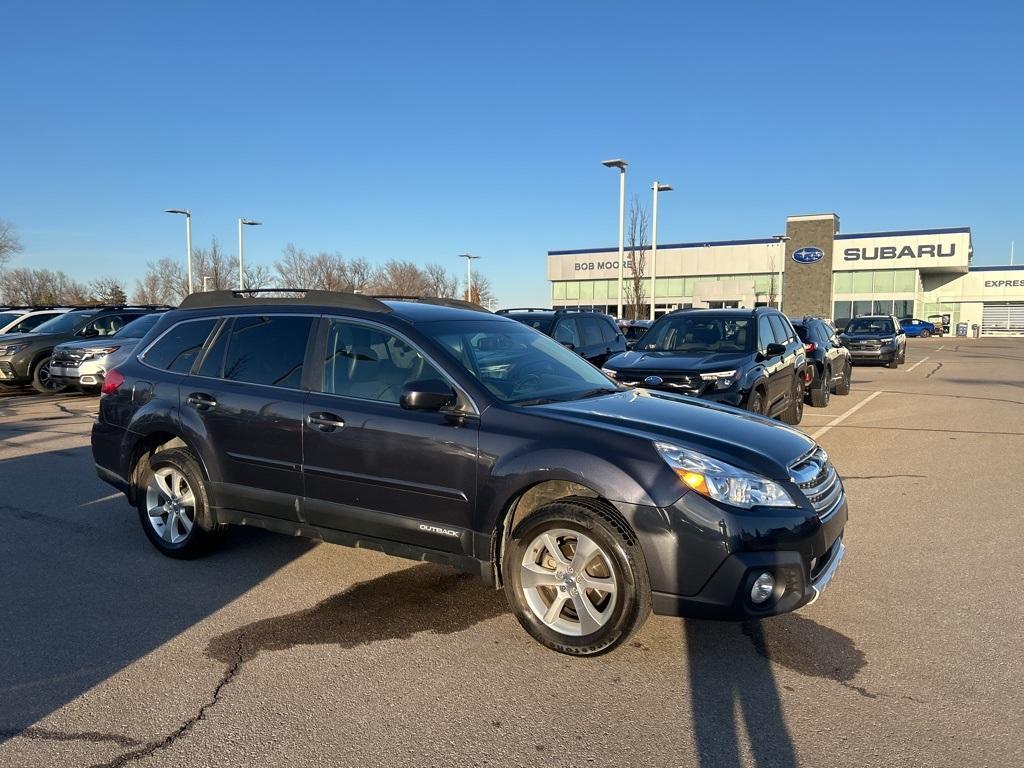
[0,0,1024,305]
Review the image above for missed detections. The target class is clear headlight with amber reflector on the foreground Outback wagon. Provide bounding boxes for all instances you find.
[654,442,797,509]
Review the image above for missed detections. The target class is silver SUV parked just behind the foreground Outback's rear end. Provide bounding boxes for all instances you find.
[50,310,168,394]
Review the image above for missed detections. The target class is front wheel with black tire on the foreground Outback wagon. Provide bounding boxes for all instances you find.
[502,498,651,656]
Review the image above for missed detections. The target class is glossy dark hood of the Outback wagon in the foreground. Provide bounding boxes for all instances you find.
[535,389,815,480]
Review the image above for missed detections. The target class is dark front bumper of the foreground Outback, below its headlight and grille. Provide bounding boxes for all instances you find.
[639,493,848,621]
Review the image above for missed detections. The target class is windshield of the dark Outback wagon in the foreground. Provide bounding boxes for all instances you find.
[419,319,617,406]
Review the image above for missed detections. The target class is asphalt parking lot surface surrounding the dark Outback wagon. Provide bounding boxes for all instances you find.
[0,338,1024,768]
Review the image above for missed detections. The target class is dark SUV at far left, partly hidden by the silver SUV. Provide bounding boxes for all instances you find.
[0,304,167,393]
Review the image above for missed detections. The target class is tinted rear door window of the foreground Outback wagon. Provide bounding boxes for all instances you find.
[223,315,313,388]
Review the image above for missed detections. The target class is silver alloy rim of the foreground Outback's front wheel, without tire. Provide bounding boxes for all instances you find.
[519,528,618,637]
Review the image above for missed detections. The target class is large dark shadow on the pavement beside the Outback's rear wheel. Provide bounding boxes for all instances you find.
[0,446,315,742]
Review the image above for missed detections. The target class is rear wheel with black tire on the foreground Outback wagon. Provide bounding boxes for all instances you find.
[135,449,226,560]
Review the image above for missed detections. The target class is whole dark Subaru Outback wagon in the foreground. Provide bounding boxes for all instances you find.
[92,291,847,655]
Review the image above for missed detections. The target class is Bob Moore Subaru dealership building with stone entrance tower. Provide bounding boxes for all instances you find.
[548,213,1024,334]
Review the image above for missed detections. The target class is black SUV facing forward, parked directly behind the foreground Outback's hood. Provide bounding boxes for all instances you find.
[602,307,807,424]
